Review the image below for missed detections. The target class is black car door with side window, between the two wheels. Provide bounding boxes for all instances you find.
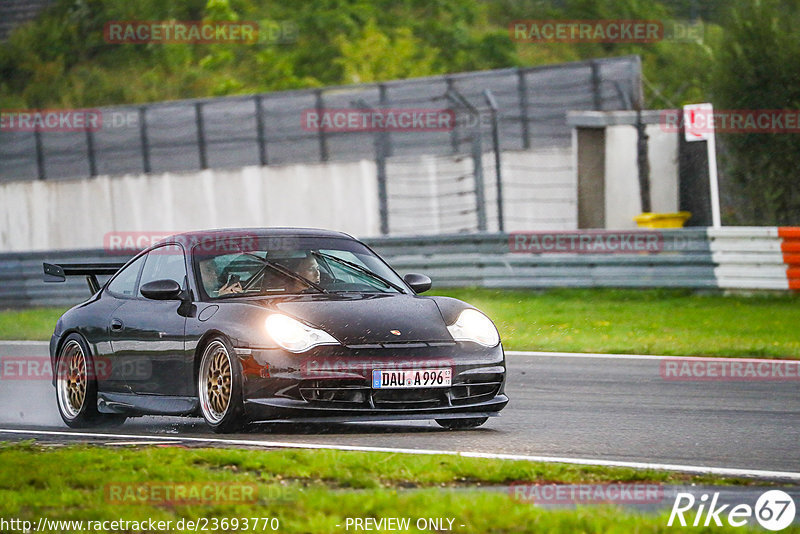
[111,245,192,396]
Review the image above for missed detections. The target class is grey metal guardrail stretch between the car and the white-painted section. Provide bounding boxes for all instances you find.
[367,229,717,289]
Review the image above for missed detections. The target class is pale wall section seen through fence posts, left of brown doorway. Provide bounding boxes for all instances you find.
[386,148,578,235]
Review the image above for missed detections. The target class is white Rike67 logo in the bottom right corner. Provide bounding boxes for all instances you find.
[667,490,795,531]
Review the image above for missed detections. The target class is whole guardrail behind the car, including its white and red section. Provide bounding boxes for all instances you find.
[0,227,800,308]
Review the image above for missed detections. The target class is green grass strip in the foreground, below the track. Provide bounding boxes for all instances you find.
[0,442,798,533]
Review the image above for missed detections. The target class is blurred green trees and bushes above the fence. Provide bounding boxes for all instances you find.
[0,0,708,107]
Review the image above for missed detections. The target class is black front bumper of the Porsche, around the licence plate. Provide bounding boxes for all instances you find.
[237,343,508,422]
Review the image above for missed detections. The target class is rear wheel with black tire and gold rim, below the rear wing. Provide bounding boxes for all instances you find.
[55,334,127,428]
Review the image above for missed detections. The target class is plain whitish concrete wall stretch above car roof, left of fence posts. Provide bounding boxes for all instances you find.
[0,161,379,251]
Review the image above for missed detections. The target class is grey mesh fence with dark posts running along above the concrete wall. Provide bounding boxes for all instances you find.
[0,56,641,181]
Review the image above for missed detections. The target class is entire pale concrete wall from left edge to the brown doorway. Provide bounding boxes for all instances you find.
[0,149,577,252]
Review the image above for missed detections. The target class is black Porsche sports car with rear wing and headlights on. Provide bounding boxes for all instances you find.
[44,228,508,432]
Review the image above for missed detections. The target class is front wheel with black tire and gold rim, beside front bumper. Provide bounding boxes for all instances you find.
[197,337,244,433]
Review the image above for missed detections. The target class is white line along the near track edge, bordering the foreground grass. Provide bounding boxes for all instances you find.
[0,428,800,480]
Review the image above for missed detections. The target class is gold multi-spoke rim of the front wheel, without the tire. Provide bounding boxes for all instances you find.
[198,340,232,424]
